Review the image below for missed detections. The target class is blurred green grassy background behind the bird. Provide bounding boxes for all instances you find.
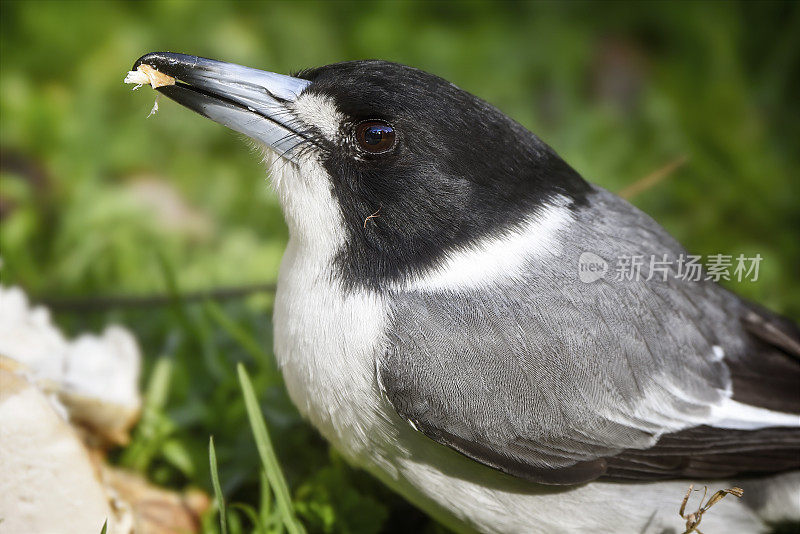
[0,0,800,533]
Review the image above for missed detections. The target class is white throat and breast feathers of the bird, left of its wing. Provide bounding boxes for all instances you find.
[265,152,396,464]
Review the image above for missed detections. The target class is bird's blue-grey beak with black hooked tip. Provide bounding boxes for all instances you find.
[133,52,310,158]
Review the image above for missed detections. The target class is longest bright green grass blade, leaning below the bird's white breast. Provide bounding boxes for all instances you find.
[236,363,305,534]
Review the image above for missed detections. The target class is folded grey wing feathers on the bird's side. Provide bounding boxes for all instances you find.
[378,188,800,484]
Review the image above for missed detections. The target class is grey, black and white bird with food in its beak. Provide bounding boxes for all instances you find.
[126,52,800,533]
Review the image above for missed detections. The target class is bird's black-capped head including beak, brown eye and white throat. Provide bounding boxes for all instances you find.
[134,52,589,287]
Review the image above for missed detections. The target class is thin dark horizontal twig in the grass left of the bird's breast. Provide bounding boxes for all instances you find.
[33,284,275,312]
